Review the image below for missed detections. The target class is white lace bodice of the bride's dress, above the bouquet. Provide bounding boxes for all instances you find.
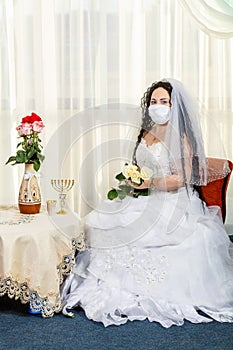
[136,139,171,177]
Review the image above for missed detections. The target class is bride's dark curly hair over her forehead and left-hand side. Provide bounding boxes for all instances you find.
[133,80,172,164]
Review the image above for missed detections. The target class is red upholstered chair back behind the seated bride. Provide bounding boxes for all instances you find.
[198,158,233,222]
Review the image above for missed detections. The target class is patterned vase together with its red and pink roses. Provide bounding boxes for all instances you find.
[6,113,44,214]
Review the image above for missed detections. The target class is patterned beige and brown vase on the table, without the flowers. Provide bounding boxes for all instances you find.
[18,163,41,214]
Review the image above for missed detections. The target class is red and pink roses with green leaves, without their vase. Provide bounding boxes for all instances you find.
[6,113,44,171]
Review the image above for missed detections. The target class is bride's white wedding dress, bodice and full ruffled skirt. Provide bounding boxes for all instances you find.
[61,140,233,327]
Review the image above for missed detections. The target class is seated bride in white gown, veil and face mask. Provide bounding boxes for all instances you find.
[61,79,233,327]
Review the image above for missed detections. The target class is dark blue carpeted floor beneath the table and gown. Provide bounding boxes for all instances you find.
[0,297,233,350]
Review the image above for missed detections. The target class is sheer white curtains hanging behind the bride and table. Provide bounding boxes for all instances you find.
[0,0,233,223]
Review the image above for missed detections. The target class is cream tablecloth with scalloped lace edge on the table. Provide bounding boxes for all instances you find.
[0,208,85,317]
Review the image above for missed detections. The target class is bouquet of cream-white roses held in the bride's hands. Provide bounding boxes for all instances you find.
[107,163,153,200]
